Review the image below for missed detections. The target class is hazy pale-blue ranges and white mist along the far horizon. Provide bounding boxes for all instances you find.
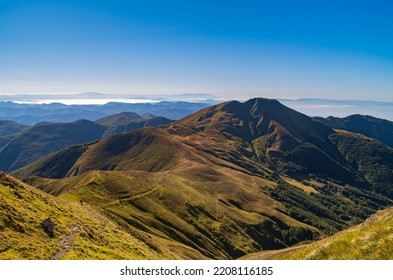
[0,93,393,125]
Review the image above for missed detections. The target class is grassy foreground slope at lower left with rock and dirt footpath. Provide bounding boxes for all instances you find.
[0,173,205,259]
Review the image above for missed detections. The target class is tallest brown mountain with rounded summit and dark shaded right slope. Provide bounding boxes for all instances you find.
[170,98,361,183]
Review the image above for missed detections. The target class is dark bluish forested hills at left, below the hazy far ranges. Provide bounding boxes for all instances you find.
[0,112,172,172]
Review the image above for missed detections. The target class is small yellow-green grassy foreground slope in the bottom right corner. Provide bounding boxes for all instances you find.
[244,208,393,260]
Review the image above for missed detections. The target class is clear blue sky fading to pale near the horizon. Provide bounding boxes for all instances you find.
[0,0,393,101]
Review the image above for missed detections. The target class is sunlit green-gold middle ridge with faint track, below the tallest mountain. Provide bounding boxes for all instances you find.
[26,165,318,259]
